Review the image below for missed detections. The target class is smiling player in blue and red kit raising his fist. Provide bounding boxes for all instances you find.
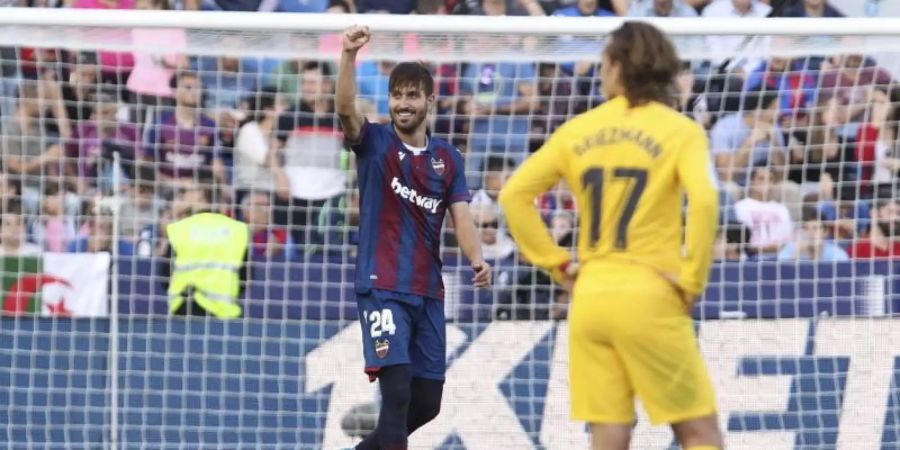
[335,26,491,450]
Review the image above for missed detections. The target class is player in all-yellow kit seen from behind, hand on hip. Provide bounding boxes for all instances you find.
[500,22,722,450]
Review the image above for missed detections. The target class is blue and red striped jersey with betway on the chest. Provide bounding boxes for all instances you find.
[350,121,469,299]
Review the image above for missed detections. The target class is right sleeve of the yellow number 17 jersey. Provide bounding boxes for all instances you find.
[677,128,719,295]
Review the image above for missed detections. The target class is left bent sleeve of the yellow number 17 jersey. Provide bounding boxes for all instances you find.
[500,127,571,273]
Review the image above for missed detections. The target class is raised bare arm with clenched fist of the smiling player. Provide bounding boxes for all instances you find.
[334,25,369,143]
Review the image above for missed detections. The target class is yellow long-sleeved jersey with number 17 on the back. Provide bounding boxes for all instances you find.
[500,96,718,294]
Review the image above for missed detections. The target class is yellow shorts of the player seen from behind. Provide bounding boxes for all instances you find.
[569,266,716,425]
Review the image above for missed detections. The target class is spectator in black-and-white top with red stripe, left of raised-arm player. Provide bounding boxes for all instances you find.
[276,62,347,245]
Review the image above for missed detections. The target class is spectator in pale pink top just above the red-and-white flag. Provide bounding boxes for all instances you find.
[33,180,77,253]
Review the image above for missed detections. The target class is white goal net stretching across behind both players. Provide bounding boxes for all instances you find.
[0,9,900,450]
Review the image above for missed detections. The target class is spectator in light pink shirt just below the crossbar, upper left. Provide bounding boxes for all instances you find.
[127,0,189,123]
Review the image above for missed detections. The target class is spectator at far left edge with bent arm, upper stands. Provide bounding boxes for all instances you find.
[0,81,65,214]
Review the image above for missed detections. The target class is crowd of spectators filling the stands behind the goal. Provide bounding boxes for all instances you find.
[0,0,900,318]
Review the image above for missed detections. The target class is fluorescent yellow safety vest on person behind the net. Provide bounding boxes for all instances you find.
[166,213,249,319]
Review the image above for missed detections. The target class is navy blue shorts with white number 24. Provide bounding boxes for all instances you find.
[356,289,447,381]
